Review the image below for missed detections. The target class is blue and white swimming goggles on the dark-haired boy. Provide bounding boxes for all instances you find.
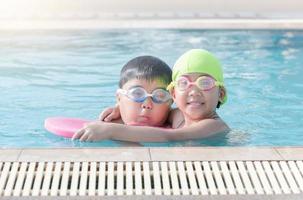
[117,87,171,104]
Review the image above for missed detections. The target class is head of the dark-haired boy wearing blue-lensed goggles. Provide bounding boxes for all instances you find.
[74,56,172,141]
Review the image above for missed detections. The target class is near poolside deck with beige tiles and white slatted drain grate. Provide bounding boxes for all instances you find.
[0,147,303,199]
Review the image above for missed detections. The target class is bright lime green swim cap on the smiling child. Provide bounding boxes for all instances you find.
[172,49,227,104]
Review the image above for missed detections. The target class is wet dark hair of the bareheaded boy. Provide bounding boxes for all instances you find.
[119,56,172,88]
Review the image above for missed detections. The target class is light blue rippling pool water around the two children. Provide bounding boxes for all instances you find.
[0,30,303,147]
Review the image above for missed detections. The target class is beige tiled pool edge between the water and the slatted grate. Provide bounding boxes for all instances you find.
[0,146,303,162]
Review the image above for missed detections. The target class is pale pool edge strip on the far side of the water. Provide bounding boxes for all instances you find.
[0,18,303,30]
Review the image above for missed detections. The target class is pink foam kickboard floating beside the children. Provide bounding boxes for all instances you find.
[44,117,91,138]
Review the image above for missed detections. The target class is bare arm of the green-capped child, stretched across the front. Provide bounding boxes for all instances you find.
[73,119,230,142]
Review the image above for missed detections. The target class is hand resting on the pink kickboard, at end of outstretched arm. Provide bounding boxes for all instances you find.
[72,121,110,142]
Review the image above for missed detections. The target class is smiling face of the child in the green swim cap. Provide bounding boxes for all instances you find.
[172,73,225,121]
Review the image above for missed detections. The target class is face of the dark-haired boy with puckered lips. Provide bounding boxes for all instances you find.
[117,79,172,126]
